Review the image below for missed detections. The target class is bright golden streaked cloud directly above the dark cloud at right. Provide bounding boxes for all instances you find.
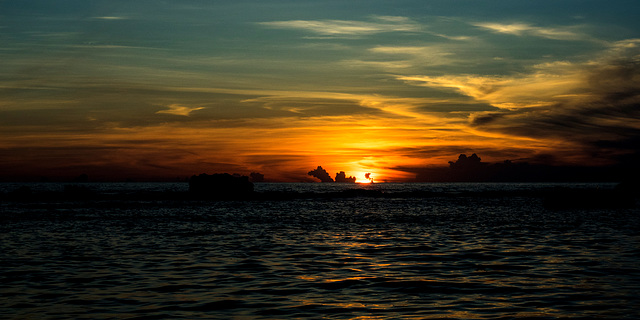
[396,39,640,110]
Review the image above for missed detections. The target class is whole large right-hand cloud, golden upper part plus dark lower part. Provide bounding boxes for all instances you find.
[398,39,640,161]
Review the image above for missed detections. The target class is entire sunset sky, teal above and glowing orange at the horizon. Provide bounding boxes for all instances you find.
[0,0,640,181]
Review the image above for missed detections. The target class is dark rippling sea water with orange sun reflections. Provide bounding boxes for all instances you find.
[0,184,640,319]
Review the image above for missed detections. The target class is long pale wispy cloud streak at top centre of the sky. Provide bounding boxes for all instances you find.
[259,16,422,36]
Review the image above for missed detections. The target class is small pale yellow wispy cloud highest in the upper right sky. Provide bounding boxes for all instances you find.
[472,22,586,40]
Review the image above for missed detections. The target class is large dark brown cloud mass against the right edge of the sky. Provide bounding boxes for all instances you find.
[471,48,640,165]
